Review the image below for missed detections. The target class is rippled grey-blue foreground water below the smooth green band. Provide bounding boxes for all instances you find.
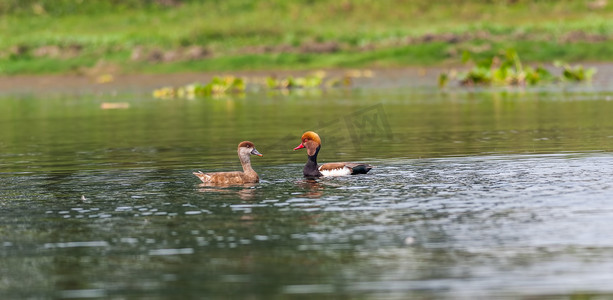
[0,153,613,298]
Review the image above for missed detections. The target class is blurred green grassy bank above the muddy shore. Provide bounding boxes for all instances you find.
[0,0,613,74]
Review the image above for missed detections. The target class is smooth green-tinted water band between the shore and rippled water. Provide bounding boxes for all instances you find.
[0,89,613,172]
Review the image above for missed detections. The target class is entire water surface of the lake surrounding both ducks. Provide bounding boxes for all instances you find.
[0,89,613,299]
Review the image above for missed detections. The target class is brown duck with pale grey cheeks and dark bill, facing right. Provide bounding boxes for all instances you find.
[193,141,263,185]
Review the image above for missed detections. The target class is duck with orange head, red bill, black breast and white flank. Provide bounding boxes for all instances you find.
[294,131,373,177]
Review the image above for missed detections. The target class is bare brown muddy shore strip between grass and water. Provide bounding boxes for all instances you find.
[0,63,613,94]
